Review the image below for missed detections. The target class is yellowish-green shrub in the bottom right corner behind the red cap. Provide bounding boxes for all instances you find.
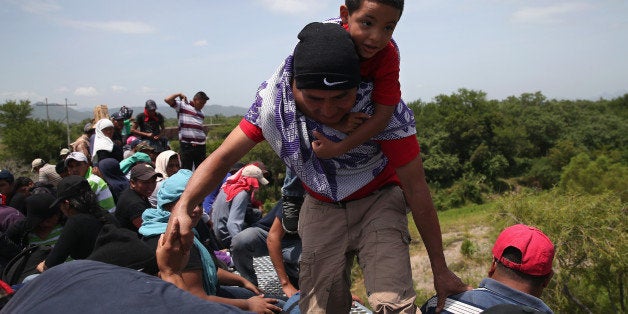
[499,189,628,313]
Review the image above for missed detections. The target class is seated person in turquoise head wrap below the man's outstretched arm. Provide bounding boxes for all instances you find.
[139,169,283,312]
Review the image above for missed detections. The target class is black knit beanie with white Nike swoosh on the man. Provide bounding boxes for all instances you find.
[293,22,361,90]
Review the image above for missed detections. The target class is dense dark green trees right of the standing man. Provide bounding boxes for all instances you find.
[409,89,628,209]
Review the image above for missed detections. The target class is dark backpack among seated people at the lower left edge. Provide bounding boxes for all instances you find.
[2,244,52,285]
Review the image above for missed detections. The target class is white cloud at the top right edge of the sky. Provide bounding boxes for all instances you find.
[511,2,591,24]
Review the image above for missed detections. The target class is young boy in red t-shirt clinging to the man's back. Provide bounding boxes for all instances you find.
[282,0,404,233]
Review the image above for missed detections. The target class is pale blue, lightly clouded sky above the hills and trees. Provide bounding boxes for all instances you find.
[0,0,628,114]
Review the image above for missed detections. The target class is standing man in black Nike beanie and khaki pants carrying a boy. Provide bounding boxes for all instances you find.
[171,23,468,313]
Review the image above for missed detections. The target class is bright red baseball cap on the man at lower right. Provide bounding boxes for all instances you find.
[493,224,554,276]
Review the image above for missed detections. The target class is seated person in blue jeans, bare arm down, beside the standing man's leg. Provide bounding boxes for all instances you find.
[231,201,301,297]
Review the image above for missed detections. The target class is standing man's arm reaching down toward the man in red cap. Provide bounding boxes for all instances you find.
[396,155,471,311]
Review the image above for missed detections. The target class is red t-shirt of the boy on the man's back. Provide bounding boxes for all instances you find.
[342,24,401,106]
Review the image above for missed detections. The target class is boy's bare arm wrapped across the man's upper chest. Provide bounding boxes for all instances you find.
[312,104,396,159]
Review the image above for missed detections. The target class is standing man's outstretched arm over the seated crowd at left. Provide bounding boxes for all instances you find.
[168,126,257,250]
